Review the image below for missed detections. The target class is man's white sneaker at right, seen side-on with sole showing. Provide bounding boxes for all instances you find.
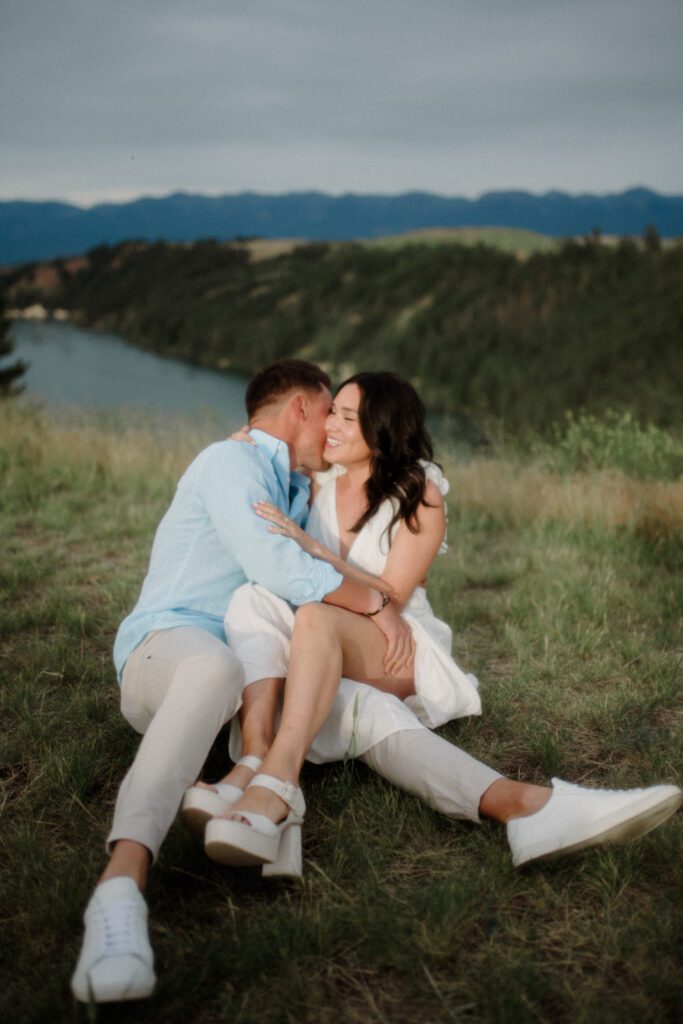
[507,778,683,867]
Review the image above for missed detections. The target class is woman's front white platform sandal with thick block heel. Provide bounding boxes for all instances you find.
[204,775,306,878]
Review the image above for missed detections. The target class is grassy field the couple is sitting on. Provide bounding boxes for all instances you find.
[0,402,683,1024]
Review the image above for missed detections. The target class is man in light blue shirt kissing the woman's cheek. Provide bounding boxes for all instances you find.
[72,360,681,1001]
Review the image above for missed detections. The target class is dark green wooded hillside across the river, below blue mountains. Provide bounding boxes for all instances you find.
[4,232,683,431]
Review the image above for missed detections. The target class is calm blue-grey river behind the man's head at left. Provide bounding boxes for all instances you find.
[10,321,247,430]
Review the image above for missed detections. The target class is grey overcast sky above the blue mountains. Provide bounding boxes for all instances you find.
[0,0,683,205]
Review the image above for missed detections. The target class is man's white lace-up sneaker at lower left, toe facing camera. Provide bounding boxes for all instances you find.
[71,878,157,1002]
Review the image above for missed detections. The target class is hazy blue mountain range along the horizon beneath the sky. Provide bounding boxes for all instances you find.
[0,188,683,264]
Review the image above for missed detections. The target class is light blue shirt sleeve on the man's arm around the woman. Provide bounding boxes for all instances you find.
[198,441,343,605]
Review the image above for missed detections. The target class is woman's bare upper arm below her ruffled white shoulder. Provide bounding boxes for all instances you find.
[383,480,445,608]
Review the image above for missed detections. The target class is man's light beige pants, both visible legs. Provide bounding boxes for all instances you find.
[108,627,501,858]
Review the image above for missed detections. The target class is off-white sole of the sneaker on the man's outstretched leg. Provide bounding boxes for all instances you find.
[513,786,683,867]
